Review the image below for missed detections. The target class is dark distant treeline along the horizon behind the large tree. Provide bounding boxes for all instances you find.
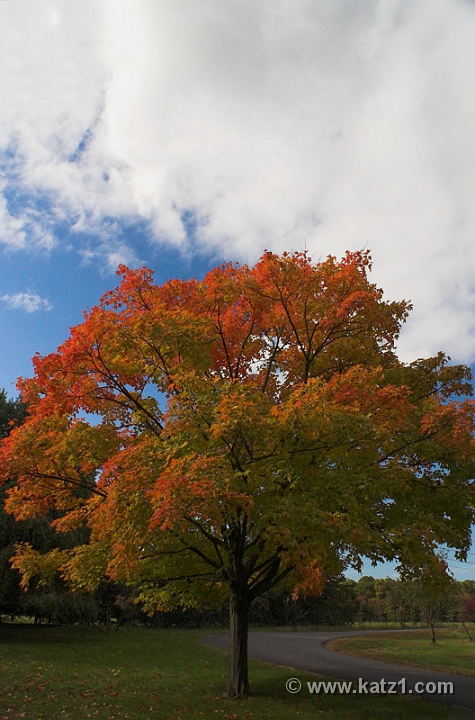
[0,567,475,627]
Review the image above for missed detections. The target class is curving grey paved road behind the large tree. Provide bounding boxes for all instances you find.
[203,630,475,710]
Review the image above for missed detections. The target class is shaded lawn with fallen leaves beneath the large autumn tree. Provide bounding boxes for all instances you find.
[0,625,474,720]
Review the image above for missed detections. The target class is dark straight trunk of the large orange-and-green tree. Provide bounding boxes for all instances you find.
[226,587,250,697]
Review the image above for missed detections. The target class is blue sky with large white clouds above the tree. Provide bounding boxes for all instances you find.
[0,0,475,576]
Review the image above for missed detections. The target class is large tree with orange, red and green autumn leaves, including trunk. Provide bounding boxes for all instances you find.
[0,252,474,696]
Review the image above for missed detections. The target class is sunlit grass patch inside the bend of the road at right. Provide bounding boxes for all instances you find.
[327,628,475,677]
